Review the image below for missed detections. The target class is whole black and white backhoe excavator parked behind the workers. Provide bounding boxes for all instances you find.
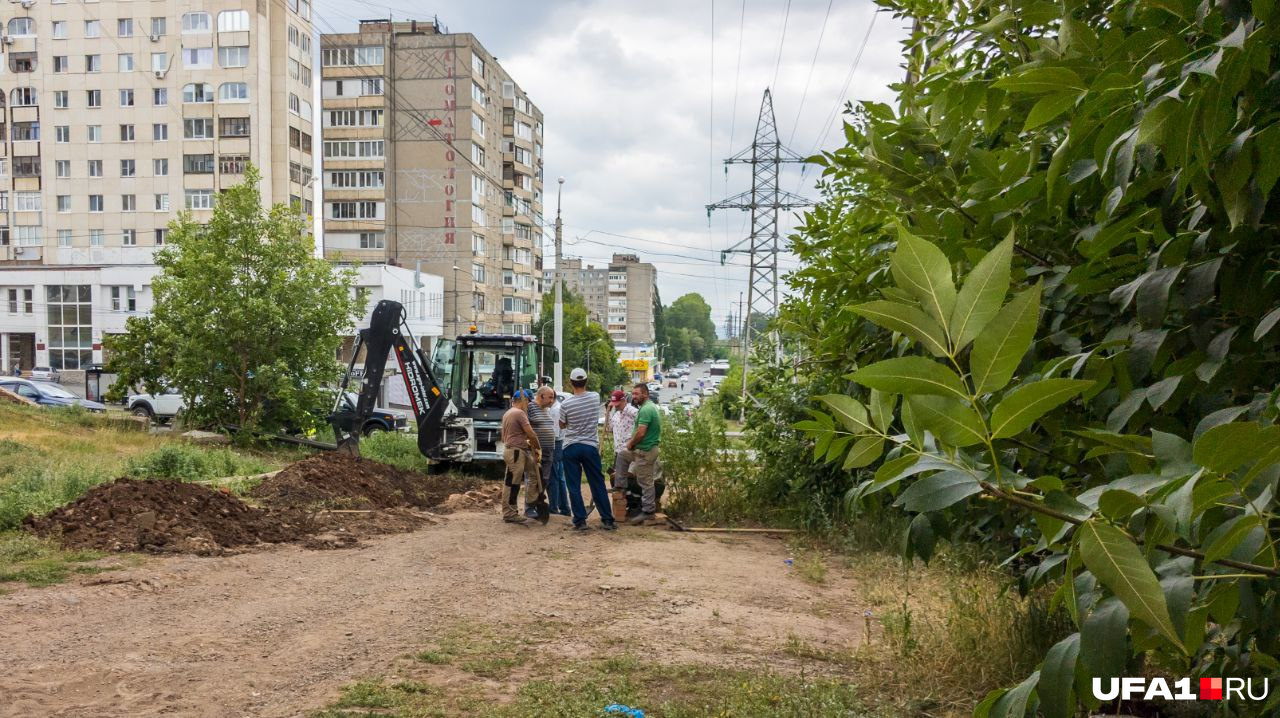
[330,299,554,471]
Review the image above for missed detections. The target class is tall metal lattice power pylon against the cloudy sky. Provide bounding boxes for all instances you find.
[707,88,813,410]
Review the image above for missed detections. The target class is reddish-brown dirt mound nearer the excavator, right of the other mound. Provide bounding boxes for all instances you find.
[250,452,471,509]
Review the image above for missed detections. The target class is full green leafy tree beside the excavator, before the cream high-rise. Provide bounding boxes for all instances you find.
[106,168,360,436]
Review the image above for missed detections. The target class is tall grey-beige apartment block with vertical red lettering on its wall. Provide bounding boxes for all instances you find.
[320,20,543,335]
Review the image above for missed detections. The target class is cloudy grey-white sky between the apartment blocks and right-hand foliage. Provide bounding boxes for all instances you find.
[316,0,905,330]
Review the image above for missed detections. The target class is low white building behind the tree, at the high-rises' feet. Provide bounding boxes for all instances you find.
[0,264,444,381]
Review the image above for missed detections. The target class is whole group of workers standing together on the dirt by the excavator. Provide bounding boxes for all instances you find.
[500,369,662,531]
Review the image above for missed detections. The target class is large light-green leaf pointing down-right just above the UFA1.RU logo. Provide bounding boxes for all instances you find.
[1075,520,1185,653]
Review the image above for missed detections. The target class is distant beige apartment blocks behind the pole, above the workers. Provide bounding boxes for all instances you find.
[544,255,658,344]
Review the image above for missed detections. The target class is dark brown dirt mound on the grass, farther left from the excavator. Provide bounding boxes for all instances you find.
[23,479,312,554]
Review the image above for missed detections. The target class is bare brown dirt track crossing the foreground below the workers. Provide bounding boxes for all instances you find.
[0,509,863,717]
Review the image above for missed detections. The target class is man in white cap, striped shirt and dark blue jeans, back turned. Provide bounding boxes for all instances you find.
[559,367,617,531]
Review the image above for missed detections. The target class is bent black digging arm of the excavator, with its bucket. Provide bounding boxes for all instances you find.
[332,299,471,461]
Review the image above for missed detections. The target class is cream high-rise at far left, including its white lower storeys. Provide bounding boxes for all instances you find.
[0,0,315,370]
